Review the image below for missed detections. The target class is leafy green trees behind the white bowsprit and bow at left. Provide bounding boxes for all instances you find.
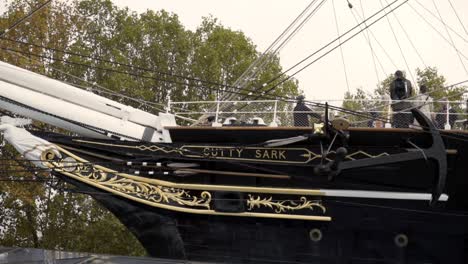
[0,0,298,255]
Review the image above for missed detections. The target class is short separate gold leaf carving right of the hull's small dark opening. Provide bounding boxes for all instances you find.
[247,194,326,214]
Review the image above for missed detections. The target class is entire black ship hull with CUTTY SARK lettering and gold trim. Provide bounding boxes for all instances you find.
[35,121,468,263]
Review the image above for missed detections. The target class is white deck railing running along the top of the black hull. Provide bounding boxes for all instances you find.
[166,99,468,129]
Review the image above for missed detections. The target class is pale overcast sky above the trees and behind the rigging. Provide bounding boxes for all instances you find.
[109,0,468,99]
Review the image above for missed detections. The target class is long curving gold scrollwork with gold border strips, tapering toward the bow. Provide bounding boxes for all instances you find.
[44,146,332,221]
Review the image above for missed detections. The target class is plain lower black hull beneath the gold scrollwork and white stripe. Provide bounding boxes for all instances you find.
[63,175,468,263]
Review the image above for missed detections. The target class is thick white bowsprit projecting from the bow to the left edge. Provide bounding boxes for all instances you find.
[0,62,175,142]
